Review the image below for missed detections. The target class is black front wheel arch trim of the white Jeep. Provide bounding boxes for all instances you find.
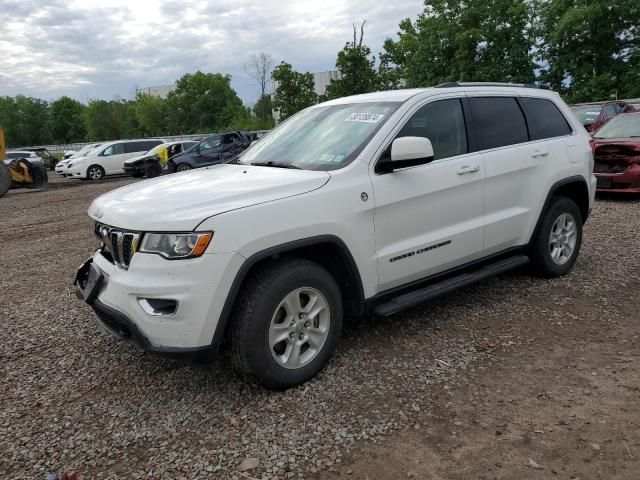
[211,235,364,351]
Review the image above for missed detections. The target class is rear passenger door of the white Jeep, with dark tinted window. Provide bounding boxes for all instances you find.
[469,95,566,255]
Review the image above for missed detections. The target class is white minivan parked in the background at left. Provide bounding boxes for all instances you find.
[64,139,162,180]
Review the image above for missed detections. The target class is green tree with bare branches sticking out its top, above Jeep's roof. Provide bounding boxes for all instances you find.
[326,22,380,99]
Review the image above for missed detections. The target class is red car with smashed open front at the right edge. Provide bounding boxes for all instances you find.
[593,113,640,193]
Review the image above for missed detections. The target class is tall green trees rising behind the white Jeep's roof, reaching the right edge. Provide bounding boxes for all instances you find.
[273,0,640,118]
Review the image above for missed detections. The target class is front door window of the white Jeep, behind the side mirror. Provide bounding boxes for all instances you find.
[396,98,468,159]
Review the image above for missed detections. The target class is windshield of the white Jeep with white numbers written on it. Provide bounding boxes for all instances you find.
[239,102,400,171]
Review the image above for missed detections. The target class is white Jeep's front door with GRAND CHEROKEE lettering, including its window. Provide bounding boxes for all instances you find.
[371,97,485,291]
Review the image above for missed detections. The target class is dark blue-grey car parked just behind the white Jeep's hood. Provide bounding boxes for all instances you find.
[167,131,256,173]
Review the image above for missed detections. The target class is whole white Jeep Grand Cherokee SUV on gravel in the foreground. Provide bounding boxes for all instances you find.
[76,83,596,389]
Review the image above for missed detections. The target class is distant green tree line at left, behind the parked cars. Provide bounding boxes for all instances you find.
[0,71,273,147]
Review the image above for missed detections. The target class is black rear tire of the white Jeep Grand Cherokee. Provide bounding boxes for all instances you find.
[531,197,582,278]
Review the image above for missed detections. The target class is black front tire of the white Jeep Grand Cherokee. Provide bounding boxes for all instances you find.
[229,258,343,390]
